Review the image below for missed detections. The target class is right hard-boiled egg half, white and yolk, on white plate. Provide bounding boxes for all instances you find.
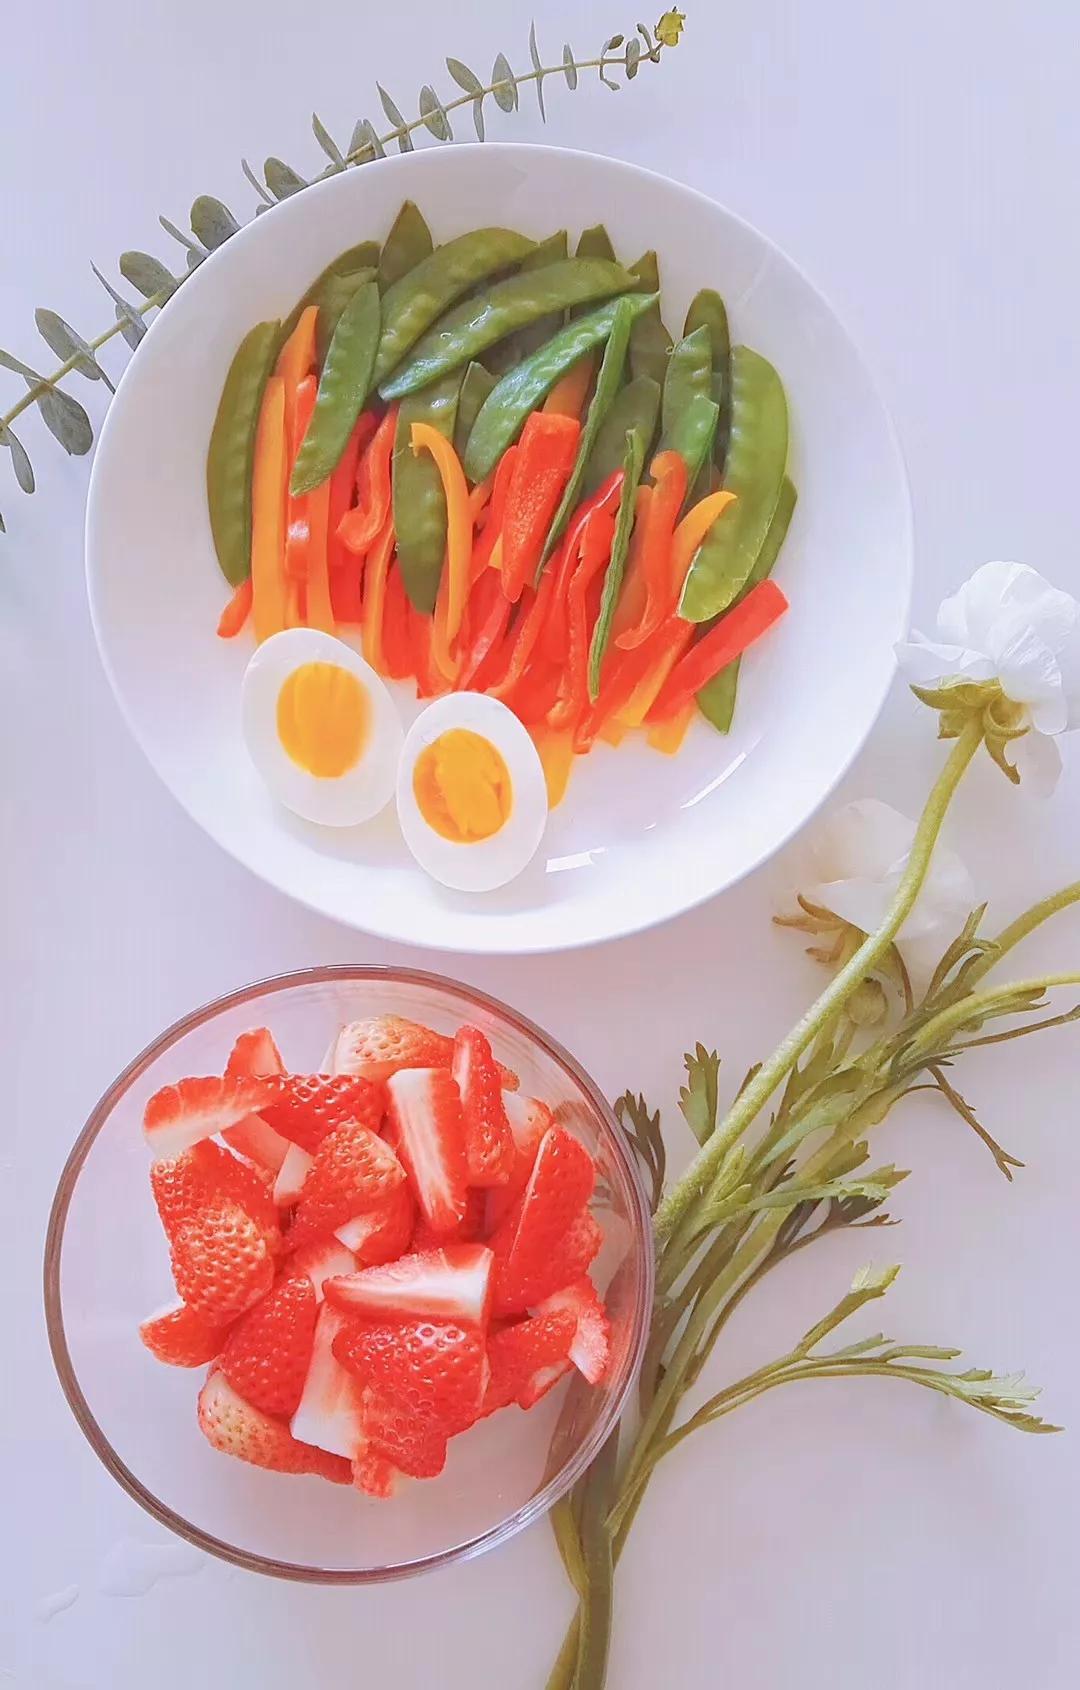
[397,693,548,892]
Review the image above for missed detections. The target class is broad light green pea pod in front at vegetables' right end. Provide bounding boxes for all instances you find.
[679,346,788,622]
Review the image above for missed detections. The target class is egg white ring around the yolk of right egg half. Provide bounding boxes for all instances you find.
[397,693,548,892]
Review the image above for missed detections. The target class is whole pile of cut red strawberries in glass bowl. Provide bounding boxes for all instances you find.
[140,1014,610,1497]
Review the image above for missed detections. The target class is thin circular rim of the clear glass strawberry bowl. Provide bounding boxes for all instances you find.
[44,963,654,1585]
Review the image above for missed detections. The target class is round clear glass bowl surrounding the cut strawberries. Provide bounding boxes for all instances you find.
[46,967,652,1584]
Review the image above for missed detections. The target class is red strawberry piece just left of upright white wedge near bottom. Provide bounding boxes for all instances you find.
[218,1274,318,1420]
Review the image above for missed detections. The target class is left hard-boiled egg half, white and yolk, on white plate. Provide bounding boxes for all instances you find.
[242,629,402,828]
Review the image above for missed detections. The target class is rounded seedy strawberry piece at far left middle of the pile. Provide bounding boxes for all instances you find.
[172,1198,274,1320]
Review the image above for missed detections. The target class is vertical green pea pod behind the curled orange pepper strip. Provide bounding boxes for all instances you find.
[392,373,461,615]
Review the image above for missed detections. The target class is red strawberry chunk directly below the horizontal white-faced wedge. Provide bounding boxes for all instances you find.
[333,1320,485,1433]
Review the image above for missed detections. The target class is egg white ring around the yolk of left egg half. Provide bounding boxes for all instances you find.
[240,629,402,828]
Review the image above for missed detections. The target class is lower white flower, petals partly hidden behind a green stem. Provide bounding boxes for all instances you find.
[803,798,977,980]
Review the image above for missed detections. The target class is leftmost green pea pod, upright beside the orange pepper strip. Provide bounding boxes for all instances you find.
[206,323,281,586]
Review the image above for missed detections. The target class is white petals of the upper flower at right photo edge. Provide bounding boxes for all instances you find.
[896,563,1080,788]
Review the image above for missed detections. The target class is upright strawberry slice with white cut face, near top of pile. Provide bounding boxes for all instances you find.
[387,1068,468,1232]
